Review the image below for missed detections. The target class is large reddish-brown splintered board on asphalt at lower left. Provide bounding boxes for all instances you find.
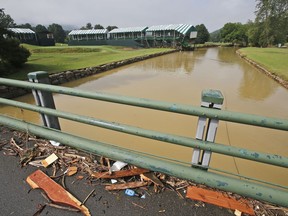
[26,170,90,216]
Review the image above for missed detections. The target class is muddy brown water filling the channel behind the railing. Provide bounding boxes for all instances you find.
[0,48,288,186]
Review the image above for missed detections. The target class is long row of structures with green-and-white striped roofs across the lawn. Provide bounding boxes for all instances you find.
[68,24,197,49]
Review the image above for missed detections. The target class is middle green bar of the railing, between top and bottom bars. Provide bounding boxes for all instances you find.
[0,98,288,168]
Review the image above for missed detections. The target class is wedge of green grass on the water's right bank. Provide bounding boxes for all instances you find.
[239,47,288,81]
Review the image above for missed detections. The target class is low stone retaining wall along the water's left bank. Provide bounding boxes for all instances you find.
[0,50,178,98]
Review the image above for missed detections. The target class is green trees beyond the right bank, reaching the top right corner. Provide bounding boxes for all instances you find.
[207,0,288,47]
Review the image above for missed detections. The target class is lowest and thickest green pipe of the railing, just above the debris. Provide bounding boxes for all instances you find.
[0,116,288,207]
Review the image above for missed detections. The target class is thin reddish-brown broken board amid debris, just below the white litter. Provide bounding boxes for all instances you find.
[91,168,150,179]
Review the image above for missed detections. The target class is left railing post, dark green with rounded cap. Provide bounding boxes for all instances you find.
[28,71,61,130]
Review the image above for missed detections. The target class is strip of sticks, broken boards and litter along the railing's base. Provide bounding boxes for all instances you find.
[0,127,288,216]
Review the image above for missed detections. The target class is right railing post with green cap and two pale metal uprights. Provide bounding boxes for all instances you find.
[192,89,224,169]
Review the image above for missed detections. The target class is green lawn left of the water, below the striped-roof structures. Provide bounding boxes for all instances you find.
[7,44,171,79]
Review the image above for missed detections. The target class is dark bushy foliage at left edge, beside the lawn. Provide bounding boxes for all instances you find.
[0,9,30,74]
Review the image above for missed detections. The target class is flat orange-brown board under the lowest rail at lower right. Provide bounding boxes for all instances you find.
[186,186,255,215]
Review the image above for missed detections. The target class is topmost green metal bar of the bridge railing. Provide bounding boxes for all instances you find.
[0,78,288,131]
